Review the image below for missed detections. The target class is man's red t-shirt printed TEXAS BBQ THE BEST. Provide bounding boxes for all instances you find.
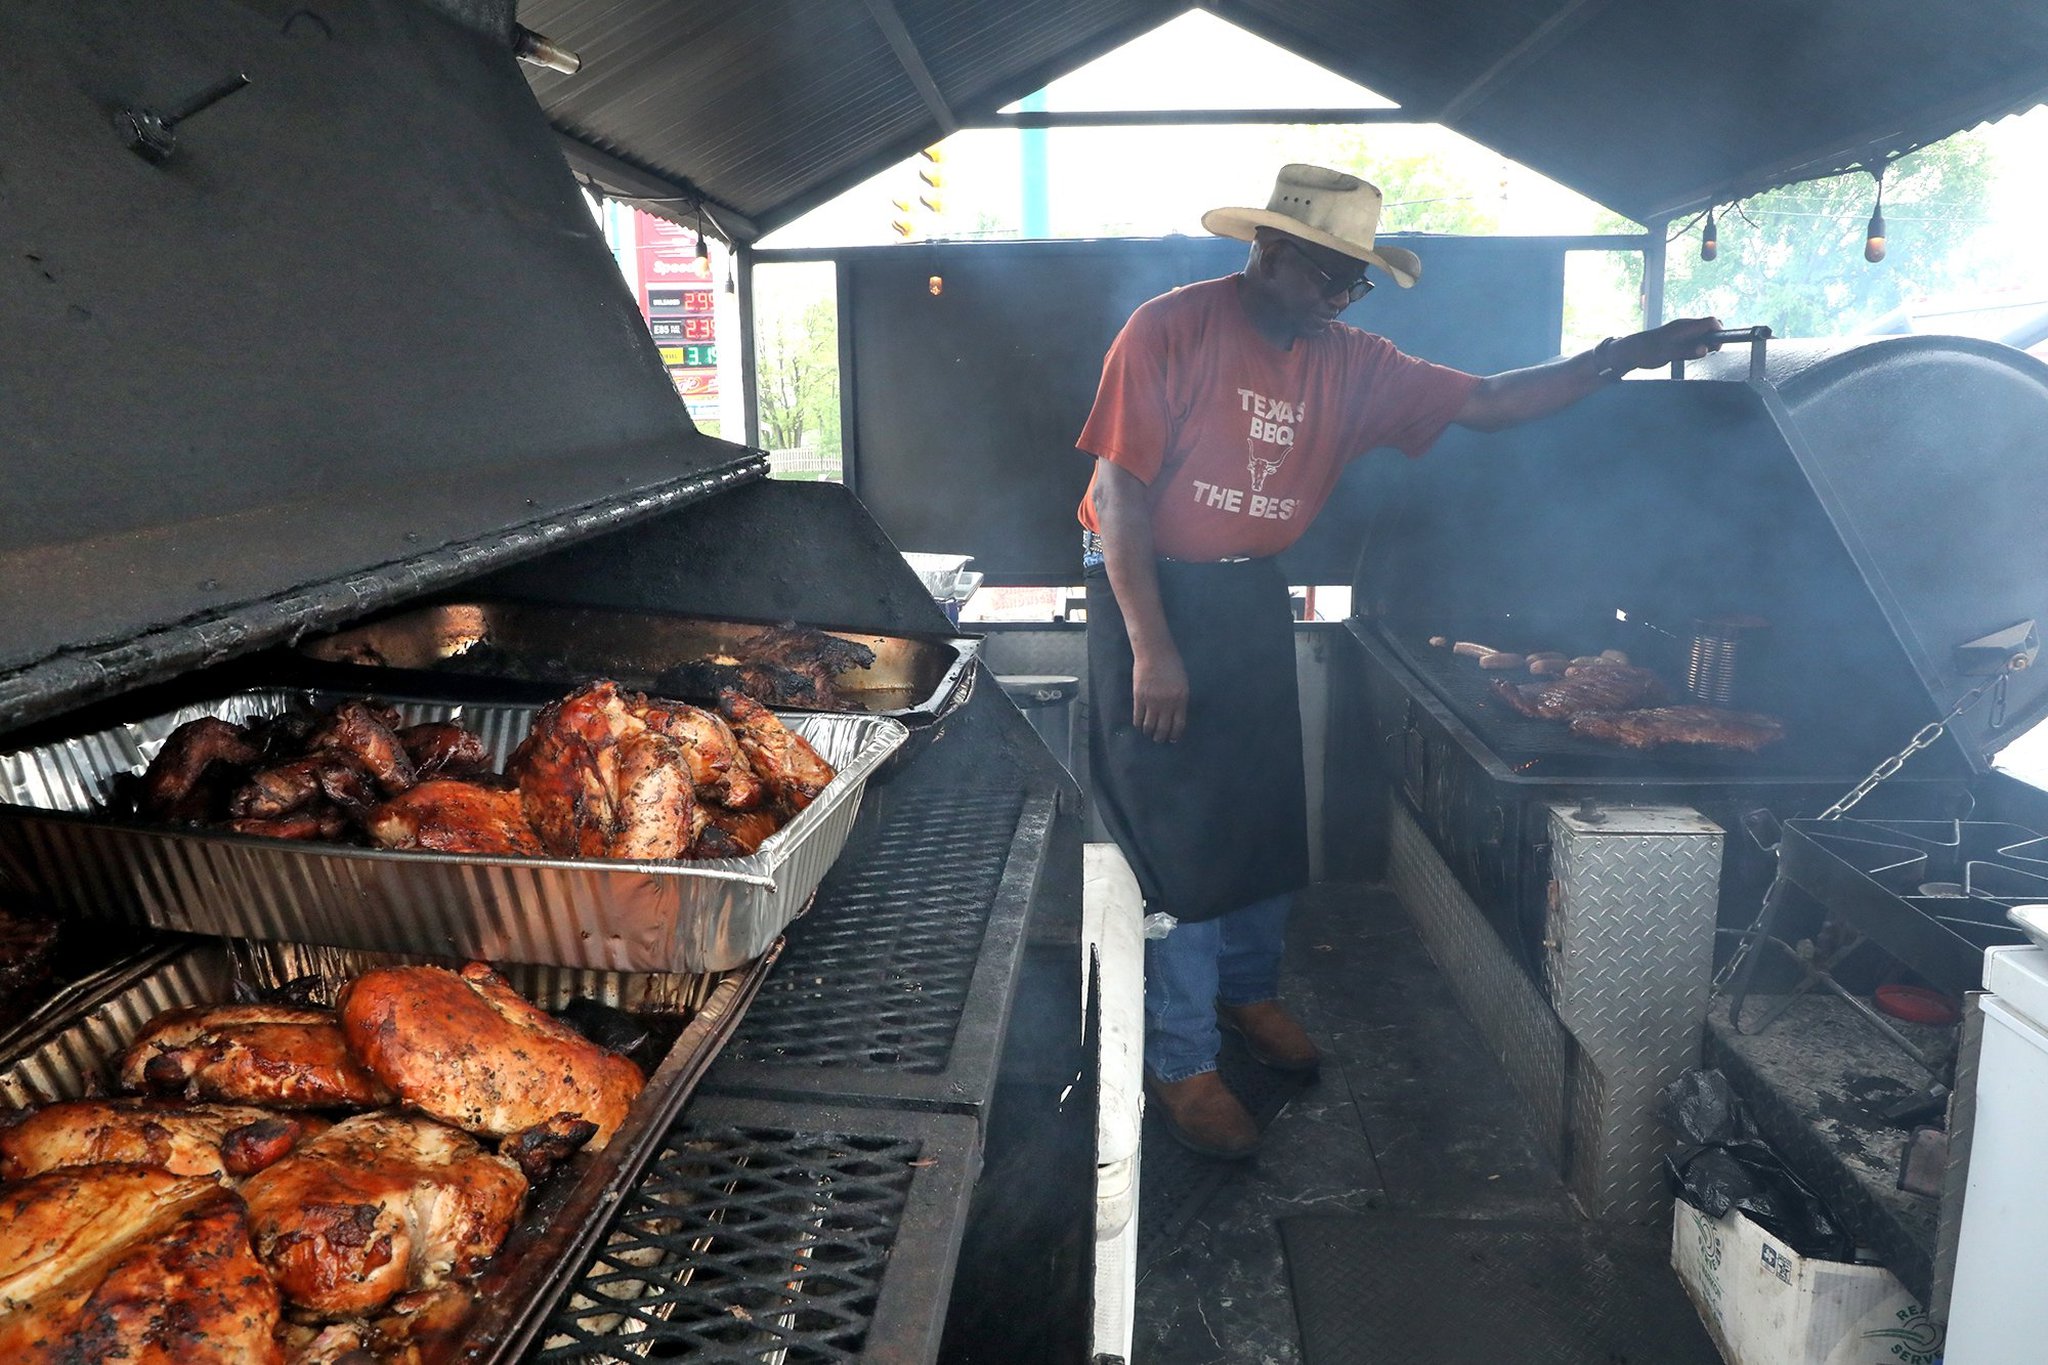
[1075,276,1479,561]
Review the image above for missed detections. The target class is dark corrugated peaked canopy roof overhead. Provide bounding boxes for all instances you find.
[520,0,2048,239]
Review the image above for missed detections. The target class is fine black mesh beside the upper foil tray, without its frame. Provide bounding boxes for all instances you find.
[721,790,1026,1074]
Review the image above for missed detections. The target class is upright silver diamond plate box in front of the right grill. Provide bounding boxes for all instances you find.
[1544,806,1722,1222]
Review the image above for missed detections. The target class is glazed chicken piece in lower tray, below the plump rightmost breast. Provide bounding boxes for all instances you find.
[242,1113,526,1318]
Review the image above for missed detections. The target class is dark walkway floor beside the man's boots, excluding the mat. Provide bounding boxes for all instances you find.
[1133,886,1577,1365]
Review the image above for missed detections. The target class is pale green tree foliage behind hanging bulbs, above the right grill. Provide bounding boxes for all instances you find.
[1665,133,1993,336]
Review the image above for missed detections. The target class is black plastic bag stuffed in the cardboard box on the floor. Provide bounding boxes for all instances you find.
[1663,1068,1855,1261]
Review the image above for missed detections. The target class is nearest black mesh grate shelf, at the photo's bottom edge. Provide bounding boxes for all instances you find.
[532,1099,975,1365]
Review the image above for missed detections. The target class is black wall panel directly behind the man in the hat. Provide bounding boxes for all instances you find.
[840,237,1563,583]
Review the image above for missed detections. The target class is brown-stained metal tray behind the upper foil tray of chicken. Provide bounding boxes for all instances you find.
[295,602,981,726]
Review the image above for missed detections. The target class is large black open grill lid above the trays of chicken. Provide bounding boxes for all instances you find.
[0,0,764,731]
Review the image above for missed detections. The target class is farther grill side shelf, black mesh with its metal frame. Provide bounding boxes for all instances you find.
[705,788,1057,1113]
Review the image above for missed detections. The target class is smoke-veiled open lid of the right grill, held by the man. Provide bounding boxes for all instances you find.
[1358,338,2048,772]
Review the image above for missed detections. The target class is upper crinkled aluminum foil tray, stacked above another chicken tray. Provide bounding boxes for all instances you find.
[0,690,907,972]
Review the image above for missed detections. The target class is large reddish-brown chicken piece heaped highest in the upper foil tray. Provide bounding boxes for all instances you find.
[506,681,702,860]
